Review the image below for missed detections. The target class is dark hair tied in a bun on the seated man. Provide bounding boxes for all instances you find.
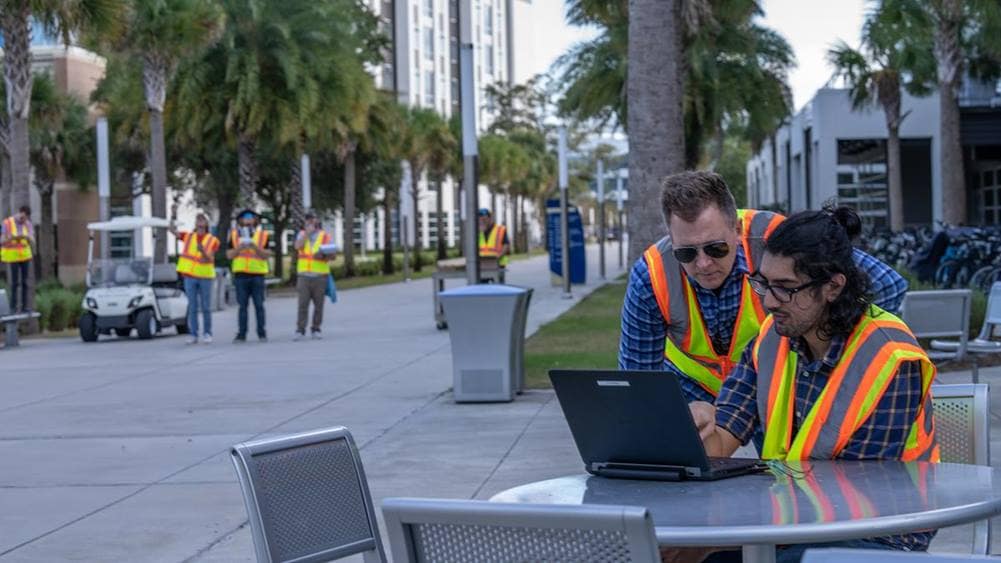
[765,205,872,340]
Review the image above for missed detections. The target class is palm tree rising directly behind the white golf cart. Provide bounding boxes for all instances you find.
[117,0,222,262]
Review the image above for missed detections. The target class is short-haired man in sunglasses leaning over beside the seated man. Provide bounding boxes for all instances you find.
[619,171,907,403]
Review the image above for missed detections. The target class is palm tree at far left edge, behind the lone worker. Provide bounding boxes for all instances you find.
[0,0,123,212]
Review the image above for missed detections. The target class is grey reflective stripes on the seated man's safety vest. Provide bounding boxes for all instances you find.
[757,317,931,460]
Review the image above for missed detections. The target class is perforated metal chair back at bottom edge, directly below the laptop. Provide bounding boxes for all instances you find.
[382,499,661,563]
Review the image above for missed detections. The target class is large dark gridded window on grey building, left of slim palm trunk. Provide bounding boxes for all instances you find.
[836,139,889,226]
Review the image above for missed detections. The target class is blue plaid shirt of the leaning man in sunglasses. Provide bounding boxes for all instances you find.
[619,245,907,403]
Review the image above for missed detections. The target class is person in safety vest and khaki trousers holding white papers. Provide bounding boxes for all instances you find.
[293,213,334,341]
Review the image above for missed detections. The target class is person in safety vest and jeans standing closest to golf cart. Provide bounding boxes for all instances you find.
[176,213,219,344]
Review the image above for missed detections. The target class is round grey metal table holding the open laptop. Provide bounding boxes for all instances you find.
[490,461,1001,563]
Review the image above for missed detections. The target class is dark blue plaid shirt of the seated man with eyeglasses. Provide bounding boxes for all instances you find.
[716,336,935,551]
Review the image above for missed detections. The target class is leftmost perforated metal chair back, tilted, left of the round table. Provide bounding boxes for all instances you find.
[231,428,385,563]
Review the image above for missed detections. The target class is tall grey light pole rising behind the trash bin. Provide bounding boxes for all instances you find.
[458,0,479,286]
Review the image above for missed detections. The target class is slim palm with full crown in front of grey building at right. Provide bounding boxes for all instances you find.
[828,10,931,230]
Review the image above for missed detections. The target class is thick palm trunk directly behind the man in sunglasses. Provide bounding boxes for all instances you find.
[627,0,685,261]
